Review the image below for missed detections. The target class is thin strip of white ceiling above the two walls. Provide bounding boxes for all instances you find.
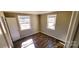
[5,11,55,14]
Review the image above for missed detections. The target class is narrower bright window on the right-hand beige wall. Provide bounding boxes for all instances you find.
[47,15,56,30]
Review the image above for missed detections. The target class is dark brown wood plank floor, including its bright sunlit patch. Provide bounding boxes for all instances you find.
[14,33,64,48]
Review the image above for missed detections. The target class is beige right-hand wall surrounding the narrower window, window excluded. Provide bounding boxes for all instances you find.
[41,11,72,42]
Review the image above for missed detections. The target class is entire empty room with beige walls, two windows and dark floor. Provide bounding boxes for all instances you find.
[0,11,79,48]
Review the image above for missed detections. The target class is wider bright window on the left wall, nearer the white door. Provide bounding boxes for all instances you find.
[18,16,31,30]
